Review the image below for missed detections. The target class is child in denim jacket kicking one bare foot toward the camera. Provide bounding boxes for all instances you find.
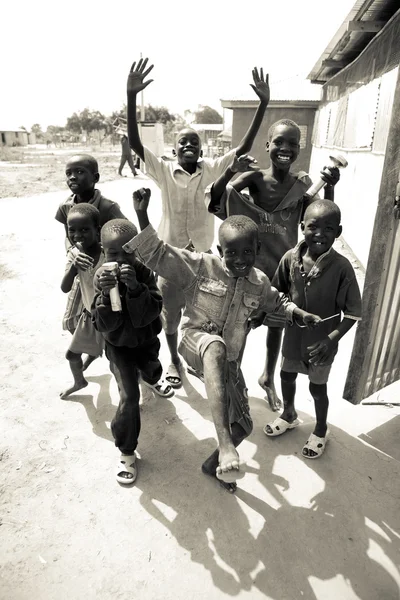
[124,188,319,492]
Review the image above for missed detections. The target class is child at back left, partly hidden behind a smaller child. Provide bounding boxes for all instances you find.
[55,154,125,333]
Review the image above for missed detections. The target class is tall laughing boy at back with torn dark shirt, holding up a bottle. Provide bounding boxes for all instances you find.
[206,119,339,410]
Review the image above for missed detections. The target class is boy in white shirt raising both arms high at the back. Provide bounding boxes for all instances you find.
[127,58,269,388]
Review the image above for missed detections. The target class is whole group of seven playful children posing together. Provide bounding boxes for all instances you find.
[56,59,361,492]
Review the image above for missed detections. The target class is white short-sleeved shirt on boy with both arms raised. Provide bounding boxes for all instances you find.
[144,147,235,252]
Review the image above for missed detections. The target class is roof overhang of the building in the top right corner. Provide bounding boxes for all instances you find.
[308,0,399,83]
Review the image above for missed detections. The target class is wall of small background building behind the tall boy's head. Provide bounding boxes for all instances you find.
[232,107,316,172]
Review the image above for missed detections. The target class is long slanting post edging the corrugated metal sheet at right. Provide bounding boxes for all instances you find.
[343,68,400,404]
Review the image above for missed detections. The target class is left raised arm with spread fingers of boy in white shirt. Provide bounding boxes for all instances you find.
[126,58,154,161]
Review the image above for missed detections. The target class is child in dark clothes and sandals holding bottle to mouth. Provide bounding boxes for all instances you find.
[92,219,174,484]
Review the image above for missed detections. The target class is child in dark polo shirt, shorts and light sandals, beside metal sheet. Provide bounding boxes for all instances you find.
[264,200,361,459]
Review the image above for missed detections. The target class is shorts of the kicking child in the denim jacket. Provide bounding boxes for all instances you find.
[179,329,253,435]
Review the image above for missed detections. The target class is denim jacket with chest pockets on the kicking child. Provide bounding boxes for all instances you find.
[123,225,295,361]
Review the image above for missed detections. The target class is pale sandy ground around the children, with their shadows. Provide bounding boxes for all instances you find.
[0,170,400,600]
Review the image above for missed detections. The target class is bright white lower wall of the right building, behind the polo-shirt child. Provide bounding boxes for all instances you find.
[310,147,385,267]
